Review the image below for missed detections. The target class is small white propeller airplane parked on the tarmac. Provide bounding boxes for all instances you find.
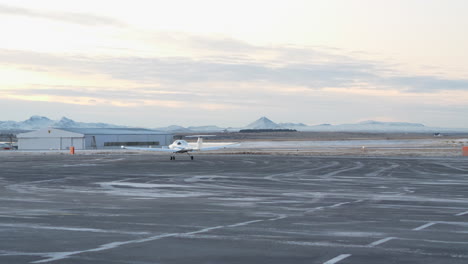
[122,135,238,160]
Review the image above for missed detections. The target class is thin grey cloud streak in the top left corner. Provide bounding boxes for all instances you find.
[0,4,125,26]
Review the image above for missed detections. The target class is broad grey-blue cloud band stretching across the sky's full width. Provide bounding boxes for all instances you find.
[0,38,468,93]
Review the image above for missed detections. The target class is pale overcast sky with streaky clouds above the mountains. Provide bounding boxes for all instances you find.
[0,0,468,128]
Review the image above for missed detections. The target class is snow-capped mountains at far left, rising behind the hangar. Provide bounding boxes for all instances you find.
[0,116,122,130]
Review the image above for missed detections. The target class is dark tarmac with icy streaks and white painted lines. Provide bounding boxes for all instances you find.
[0,154,468,264]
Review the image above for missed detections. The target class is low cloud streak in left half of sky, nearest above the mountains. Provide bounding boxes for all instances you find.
[0,82,249,110]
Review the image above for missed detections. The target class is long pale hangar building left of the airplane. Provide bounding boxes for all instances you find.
[17,128,173,150]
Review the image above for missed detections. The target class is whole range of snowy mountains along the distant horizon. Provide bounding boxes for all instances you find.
[0,115,468,133]
